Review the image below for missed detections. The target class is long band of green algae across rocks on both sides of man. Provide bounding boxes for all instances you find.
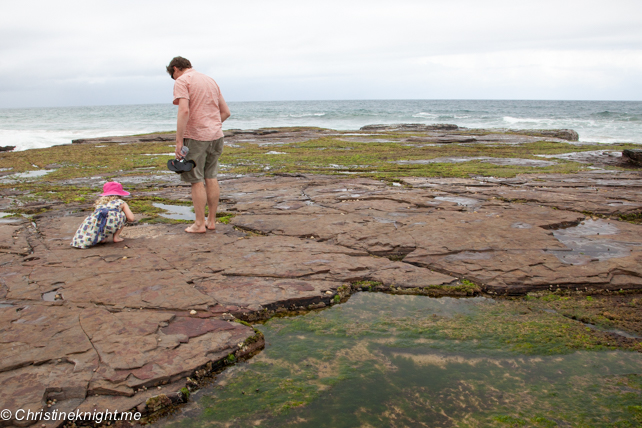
[0,137,633,187]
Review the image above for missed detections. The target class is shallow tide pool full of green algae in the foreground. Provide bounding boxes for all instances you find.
[160,293,642,427]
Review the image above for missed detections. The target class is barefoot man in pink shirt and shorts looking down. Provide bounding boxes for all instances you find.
[167,56,231,233]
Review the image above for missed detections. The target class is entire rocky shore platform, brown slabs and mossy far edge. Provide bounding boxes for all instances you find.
[0,125,642,426]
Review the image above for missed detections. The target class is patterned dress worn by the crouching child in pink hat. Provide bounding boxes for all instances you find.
[71,199,127,248]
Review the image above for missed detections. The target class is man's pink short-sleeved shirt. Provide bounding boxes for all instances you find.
[174,68,223,141]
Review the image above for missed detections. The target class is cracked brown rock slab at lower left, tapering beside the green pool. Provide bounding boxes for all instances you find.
[0,302,254,426]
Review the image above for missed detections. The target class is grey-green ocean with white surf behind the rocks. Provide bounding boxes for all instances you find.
[0,100,642,150]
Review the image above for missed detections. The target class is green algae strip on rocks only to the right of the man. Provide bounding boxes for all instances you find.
[221,135,600,179]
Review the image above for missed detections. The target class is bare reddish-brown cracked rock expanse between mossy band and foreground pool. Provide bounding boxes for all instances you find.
[0,169,642,422]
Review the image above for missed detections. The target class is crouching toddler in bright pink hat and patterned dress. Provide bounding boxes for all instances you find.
[71,181,134,248]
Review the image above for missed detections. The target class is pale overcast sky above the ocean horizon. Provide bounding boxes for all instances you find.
[0,0,642,108]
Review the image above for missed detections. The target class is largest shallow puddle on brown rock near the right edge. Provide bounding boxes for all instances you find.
[548,220,634,265]
